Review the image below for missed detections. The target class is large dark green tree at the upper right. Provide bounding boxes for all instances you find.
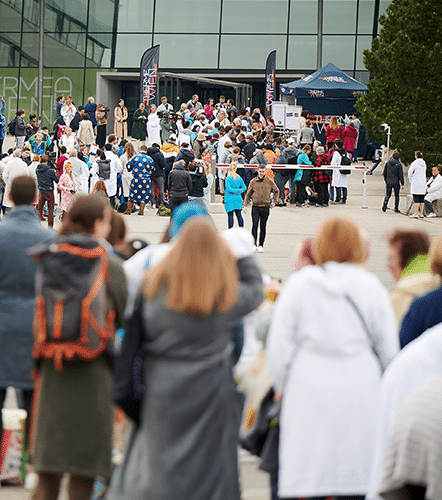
[355,0,442,164]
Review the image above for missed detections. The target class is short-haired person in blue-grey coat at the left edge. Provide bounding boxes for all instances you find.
[0,175,54,446]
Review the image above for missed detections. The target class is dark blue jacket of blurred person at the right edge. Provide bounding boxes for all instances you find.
[399,287,442,349]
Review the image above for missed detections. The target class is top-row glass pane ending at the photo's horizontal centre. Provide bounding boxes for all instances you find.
[155,0,221,33]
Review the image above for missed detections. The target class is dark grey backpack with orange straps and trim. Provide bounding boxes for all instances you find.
[32,234,115,371]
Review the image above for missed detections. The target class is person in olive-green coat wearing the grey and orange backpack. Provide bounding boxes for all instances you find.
[32,194,127,500]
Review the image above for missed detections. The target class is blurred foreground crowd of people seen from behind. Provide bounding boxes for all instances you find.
[0,169,442,500]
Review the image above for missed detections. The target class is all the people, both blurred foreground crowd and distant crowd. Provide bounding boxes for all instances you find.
[0,95,442,500]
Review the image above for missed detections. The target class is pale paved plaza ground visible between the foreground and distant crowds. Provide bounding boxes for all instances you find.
[0,154,442,500]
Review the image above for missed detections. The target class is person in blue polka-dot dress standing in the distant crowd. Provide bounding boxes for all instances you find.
[124,146,155,215]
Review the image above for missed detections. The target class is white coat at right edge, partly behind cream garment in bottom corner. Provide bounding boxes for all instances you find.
[367,324,442,500]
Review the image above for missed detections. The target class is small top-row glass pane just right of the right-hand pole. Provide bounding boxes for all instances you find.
[323,0,357,35]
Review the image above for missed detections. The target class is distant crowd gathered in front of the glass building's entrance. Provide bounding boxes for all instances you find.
[0,94,370,232]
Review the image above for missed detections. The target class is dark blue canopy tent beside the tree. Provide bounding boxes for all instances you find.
[279,63,367,152]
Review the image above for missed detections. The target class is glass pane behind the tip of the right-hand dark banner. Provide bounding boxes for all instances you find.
[220,35,287,71]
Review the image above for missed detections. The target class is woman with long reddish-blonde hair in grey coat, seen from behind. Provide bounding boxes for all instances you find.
[108,217,263,500]
